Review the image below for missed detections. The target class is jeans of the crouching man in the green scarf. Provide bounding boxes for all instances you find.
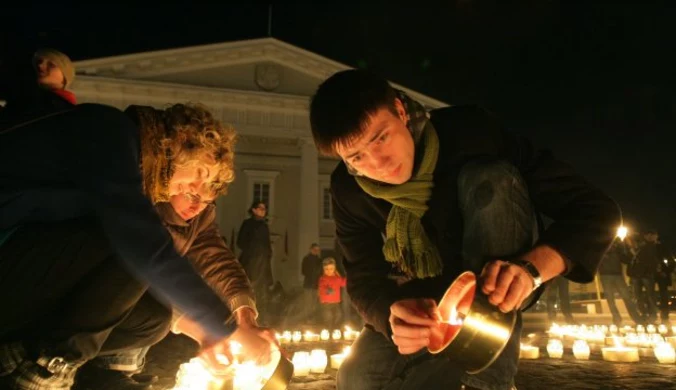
[337,161,537,390]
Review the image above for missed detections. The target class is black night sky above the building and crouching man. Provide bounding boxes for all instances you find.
[0,0,676,242]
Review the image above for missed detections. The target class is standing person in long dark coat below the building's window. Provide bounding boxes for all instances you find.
[237,200,274,323]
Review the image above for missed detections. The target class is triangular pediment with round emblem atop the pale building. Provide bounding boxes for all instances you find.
[75,38,446,108]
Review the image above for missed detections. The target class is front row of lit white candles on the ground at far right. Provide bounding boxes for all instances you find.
[519,339,676,363]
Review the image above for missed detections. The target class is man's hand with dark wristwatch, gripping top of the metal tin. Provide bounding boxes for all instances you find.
[481,245,566,313]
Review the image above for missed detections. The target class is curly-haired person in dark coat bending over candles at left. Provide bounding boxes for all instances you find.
[0,104,274,390]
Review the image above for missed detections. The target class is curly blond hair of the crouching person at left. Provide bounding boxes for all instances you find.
[163,104,237,196]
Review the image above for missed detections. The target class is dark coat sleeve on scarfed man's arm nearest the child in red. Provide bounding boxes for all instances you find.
[331,172,398,338]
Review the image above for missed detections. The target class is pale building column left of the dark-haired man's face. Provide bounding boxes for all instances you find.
[296,138,319,281]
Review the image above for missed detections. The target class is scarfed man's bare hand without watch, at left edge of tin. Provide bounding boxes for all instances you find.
[390,299,441,355]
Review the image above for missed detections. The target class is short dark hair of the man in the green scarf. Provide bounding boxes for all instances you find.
[310,69,397,156]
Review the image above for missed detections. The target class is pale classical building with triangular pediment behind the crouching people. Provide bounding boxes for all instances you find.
[73,38,445,288]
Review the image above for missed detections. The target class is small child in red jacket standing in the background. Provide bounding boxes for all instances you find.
[319,257,345,329]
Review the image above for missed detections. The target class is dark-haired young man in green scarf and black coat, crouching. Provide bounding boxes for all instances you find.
[310,70,619,390]
